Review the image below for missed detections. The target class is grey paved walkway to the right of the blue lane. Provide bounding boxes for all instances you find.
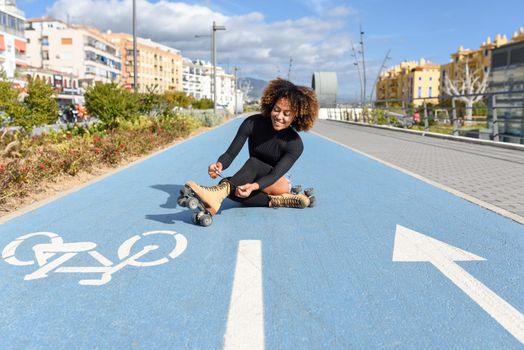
[314,120,524,220]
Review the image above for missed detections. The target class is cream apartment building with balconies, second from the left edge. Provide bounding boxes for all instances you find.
[25,18,122,87]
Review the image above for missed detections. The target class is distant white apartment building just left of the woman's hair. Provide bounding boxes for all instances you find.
[182,58,244,111]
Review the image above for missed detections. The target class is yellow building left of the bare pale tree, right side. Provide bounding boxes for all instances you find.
[376,58,440,106]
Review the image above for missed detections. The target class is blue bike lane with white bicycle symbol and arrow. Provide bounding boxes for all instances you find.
[0,120,524,349]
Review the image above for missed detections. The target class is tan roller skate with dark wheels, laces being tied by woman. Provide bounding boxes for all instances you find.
[177,181,230,227]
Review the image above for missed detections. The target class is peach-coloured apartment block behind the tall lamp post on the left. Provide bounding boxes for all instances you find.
[105,33,183,93]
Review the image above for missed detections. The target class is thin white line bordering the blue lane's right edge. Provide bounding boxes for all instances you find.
[310,131,524,225]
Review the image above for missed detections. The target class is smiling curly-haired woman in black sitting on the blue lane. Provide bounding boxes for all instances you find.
[186,78,319,215]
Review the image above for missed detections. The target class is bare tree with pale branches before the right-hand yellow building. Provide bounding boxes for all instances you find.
[444,59,490,120]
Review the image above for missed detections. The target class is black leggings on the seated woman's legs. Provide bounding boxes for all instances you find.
[222,157,273,207]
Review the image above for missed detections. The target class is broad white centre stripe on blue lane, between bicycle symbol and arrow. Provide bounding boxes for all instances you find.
[224,240,264,350]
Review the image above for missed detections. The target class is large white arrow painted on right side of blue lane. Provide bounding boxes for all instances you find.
[393,225,524,344]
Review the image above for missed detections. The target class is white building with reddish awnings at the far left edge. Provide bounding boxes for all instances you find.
[0,0,28,79]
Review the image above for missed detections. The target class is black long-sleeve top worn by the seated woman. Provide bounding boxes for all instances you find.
[218,114,304,189]
